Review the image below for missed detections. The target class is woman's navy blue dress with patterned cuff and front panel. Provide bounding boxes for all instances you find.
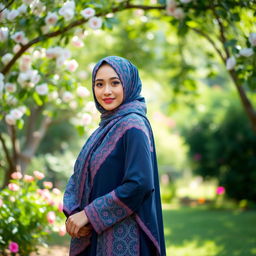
[76,114,166,256]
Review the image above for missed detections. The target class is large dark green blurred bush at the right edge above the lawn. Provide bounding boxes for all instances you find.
[185,102,256,201]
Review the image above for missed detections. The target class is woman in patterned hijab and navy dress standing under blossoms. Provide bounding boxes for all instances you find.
[63,56,166,256]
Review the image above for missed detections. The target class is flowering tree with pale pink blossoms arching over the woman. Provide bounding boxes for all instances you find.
[0,0,256,184]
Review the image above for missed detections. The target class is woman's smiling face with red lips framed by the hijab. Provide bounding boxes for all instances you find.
[94,64,124,110]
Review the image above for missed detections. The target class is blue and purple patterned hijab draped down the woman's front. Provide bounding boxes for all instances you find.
[63,56,147,216]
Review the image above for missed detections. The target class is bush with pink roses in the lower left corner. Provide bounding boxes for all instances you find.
[0,171,65,255]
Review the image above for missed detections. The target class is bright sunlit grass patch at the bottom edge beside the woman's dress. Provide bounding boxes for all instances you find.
[167,240,222,256]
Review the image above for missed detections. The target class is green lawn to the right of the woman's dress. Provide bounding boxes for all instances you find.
[163,207,256,256]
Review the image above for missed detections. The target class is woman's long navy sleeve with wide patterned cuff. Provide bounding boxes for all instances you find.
[84,128,154,234]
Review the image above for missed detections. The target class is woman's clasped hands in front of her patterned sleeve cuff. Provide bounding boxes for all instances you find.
[66,211,89,238]
